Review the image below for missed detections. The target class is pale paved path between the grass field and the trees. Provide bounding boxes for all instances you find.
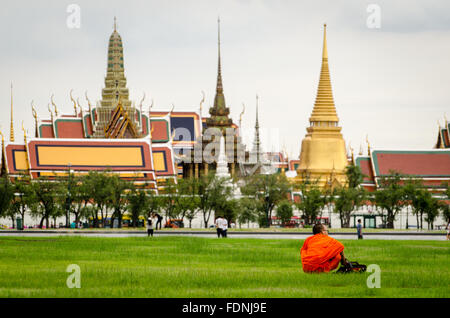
[0,230,450,240]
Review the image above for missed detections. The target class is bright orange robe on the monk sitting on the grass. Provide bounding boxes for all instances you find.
[300,233,344,273]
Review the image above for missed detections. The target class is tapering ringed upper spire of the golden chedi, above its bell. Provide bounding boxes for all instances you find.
[309,24,339,126]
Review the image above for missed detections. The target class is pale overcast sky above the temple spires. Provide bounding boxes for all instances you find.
[0,0,450,157]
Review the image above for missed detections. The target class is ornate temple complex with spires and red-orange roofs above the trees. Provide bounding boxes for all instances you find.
[0,20,450,201]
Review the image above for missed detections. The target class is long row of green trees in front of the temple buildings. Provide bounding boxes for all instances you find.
[0,165,450,228]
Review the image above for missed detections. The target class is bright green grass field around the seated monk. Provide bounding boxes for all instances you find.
[0,237,450,298]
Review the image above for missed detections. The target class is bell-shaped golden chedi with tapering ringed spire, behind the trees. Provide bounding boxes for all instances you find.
[295,24,348,188]
